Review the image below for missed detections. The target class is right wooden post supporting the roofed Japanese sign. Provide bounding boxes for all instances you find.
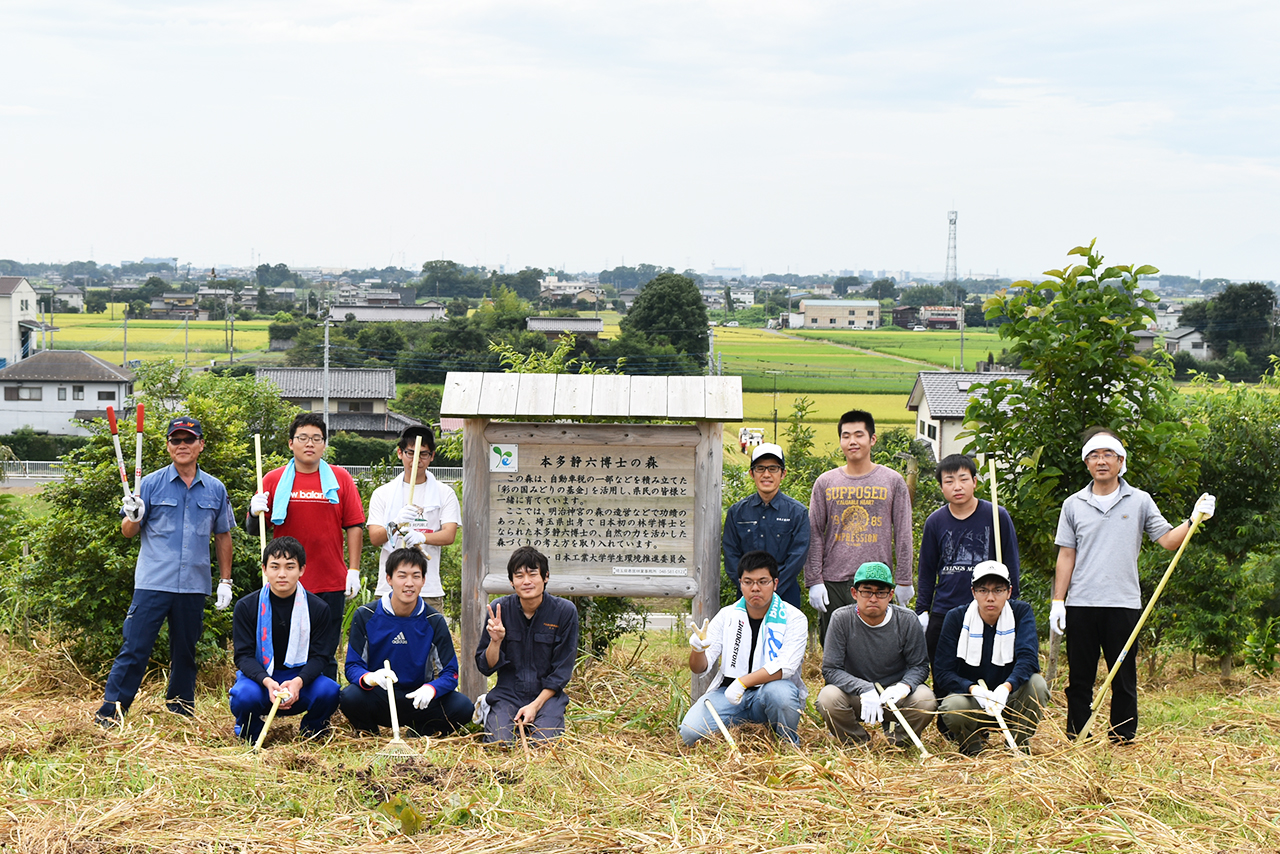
[690,421,724,699]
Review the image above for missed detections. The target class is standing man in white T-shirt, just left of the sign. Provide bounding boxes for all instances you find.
[369,426,462,613]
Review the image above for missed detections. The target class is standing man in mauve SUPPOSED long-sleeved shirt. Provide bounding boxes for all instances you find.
[804,410,915,643]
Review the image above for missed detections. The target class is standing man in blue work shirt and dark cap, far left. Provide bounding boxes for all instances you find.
[93,416,234,729]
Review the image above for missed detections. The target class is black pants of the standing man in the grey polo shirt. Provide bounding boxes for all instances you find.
[1066,606,1142,741]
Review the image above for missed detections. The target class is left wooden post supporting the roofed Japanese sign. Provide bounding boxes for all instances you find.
[458,419,489,699]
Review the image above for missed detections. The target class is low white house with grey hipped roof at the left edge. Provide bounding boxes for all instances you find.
[0,350,133,435]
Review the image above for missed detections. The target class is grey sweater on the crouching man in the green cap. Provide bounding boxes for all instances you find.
[822,604,929,694]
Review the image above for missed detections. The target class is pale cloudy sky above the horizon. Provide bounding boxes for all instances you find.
[0,0,1280,279]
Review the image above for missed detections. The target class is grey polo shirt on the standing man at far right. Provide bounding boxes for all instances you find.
[1053,478,1174,608]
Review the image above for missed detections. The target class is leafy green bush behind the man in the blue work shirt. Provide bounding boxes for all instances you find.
[18,361,297,672]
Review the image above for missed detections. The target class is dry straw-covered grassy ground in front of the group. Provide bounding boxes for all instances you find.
[0,635,1280,854]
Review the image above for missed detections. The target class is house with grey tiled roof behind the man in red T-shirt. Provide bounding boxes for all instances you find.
[255,367,419,439]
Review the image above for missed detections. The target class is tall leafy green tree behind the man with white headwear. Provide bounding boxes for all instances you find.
[960,243,1204,603]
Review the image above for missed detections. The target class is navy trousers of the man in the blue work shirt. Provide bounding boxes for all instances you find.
[102,590,209,711]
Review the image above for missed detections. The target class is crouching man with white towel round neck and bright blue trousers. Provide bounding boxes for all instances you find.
[228,536,338,741]
